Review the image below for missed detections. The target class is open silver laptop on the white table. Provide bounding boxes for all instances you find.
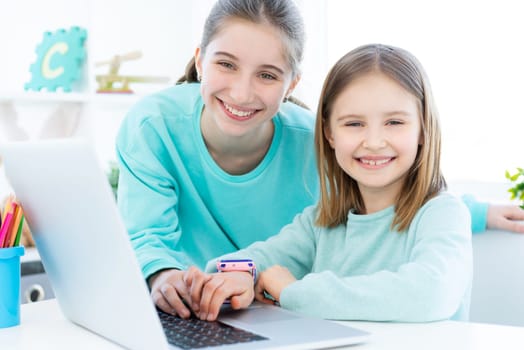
[0,139,369,350]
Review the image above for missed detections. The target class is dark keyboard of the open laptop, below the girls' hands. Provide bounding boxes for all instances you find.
[157,310,268,349]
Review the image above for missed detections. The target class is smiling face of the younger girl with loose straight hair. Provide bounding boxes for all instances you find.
[325,72,421,207]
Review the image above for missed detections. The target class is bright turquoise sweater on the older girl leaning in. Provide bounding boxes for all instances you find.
[117,84,318,277]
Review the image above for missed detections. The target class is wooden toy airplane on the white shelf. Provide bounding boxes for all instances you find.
[95,51,169,94]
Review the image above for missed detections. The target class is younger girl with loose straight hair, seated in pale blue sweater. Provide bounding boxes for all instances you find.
[190,45,472,322]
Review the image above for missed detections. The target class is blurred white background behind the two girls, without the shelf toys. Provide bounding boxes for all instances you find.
[0,0,524,196]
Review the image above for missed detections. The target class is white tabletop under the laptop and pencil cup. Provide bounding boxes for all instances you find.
[0,299,524,350]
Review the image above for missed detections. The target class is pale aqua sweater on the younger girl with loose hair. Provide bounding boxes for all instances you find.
[207,193,472,322]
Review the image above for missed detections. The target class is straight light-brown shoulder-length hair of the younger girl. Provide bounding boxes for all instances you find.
[315,44,446,232]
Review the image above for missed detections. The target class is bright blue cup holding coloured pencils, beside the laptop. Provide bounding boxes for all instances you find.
[0,246,24,328]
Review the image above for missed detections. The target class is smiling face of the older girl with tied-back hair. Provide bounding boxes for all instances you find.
[195,19,298,137]
